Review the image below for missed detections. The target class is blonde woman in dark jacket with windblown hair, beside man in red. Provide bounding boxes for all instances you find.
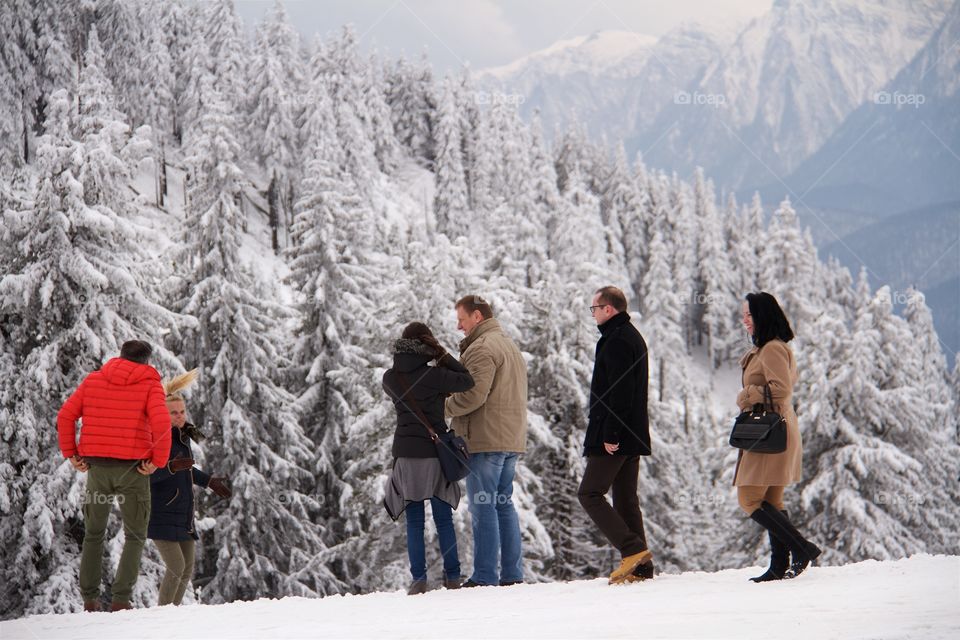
[147,370,230,606]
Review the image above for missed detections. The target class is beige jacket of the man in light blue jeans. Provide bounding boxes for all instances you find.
[446,318,527,453]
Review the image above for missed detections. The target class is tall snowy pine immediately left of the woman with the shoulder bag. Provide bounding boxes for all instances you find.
[289,63,403,591]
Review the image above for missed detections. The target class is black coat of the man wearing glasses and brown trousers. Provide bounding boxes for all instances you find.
[583,311,651,456]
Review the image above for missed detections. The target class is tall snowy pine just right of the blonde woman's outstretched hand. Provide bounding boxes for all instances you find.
[174,78,338,602]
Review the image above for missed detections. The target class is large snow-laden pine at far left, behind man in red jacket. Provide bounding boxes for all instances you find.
[0,77,183,613]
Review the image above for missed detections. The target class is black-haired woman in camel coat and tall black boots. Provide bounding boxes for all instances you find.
[733,292,820,582]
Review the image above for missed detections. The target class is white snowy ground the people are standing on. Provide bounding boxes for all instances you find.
[0,555,960,640]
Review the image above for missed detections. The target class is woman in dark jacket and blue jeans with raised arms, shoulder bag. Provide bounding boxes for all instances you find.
[383,322,474,595]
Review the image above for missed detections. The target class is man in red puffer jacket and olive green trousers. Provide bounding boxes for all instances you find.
[57,340,170,611]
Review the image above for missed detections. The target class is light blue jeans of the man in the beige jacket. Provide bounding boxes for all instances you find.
[467,451,523,585]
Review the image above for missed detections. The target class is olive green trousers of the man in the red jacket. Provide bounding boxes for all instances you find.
[80,464,150,602]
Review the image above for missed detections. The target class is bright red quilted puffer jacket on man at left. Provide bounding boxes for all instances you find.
[57,358,170,467]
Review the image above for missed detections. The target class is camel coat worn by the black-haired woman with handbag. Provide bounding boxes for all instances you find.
[733,340,803,487]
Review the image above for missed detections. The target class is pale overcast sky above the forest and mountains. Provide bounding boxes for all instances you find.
[236,0,772,72]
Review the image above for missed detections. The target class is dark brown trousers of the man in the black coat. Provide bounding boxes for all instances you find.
[577,455,647,558]
